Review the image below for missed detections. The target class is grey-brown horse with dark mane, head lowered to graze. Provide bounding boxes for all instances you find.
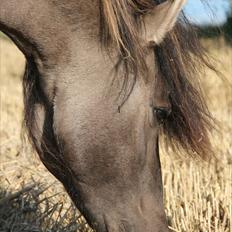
[0,0,215,232]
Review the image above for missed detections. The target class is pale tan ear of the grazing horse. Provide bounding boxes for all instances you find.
[144,0,186,44]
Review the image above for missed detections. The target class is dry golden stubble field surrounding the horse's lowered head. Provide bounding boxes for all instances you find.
[0,39,232,232]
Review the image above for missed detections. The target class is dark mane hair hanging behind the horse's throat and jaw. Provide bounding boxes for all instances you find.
[23,57,84,212]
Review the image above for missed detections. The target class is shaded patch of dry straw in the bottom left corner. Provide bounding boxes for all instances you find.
[0,183,87,232]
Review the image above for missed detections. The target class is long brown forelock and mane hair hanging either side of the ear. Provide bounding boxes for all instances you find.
[100,0,216,158]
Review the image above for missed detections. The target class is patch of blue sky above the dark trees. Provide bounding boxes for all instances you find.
[185,0,230,24]
